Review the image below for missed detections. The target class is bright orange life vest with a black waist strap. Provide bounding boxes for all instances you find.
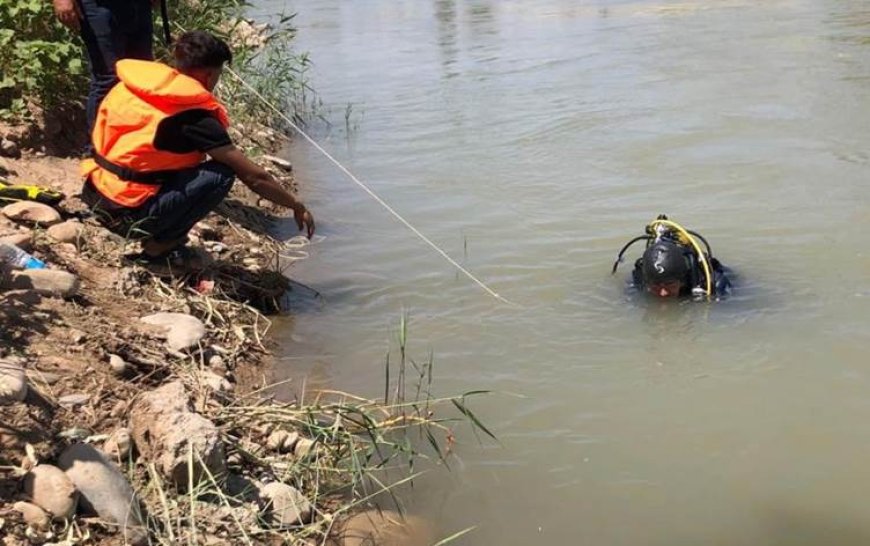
[81,59,229,208]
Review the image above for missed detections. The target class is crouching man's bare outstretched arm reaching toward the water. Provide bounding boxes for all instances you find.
[208,144,314,239]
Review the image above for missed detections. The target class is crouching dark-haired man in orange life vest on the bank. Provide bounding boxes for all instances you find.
[82,31,314,266]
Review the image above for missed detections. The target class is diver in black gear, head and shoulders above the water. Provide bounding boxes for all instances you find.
[612,214,731,300]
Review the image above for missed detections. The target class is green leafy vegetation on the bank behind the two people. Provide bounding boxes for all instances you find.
[0,0,315,130]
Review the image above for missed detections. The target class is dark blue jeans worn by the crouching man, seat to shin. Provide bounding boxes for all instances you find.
[82,161,235,242]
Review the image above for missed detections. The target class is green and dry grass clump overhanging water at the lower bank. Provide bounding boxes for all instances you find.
[138,317,495,546]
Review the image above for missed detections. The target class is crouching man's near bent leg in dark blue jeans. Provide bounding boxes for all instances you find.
[143,161,235,256]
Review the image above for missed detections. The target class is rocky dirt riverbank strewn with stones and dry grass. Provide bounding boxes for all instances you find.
[0,146,433,546]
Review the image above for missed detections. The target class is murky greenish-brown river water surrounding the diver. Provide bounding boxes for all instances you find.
[255,0,870,546]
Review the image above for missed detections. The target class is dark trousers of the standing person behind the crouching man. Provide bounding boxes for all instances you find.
[77,0,154,135]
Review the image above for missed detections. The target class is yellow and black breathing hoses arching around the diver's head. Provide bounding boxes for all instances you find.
[611,214,713,298]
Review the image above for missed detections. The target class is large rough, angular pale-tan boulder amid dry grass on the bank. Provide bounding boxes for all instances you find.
[130,382,226,488]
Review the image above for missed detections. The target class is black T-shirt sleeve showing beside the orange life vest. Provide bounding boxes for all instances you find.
[154,109,232,154]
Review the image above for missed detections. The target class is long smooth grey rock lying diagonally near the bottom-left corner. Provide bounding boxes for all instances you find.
[58,443,148,546]
